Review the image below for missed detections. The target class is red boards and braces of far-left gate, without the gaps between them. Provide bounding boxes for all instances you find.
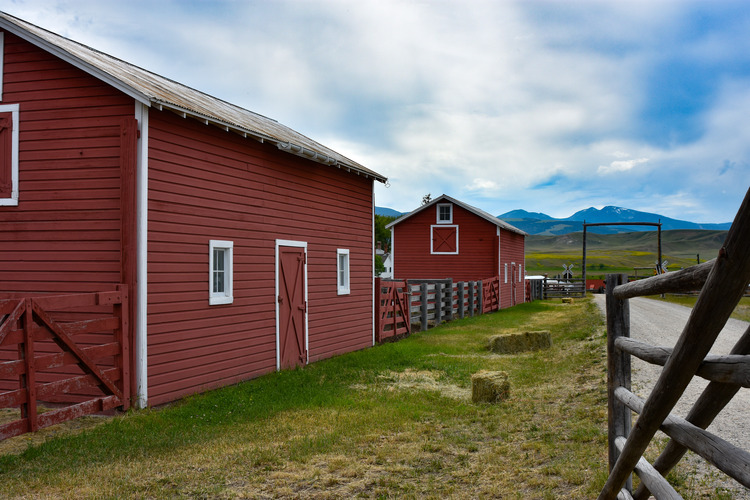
[0,285,130,440]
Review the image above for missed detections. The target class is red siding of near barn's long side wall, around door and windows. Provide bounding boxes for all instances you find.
[148,110,373,404]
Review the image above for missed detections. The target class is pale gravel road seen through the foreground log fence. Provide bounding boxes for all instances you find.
[594,295,750,499]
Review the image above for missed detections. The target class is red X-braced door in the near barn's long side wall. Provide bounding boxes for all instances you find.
[277,245,307,369]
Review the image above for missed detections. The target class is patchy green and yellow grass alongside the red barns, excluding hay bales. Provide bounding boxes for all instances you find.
[0,300,732,499]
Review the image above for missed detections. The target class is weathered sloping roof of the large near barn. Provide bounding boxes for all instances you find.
[0,12,388,183]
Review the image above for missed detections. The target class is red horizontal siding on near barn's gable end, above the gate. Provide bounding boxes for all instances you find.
[0,33,133,293]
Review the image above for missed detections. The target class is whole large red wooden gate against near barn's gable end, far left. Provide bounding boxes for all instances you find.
[0,285,130,440]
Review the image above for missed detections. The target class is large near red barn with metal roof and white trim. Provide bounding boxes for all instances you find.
[0,13,386,406]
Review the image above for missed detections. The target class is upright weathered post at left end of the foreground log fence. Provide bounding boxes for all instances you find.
[607,274,633,494]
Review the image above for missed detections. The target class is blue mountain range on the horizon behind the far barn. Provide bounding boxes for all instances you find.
[375,206,732,235]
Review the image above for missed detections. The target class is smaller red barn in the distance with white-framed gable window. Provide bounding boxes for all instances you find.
[386,195,526,308]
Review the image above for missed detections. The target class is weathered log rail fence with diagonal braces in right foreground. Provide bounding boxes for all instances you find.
[599,190,750,500]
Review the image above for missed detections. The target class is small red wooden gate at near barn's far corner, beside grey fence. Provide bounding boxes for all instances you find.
[375,278,411,342]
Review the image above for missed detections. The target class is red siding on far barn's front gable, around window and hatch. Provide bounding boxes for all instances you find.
[393,205,497,281]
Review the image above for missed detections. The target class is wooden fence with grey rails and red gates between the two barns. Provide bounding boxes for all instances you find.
[375,276,500,342]
